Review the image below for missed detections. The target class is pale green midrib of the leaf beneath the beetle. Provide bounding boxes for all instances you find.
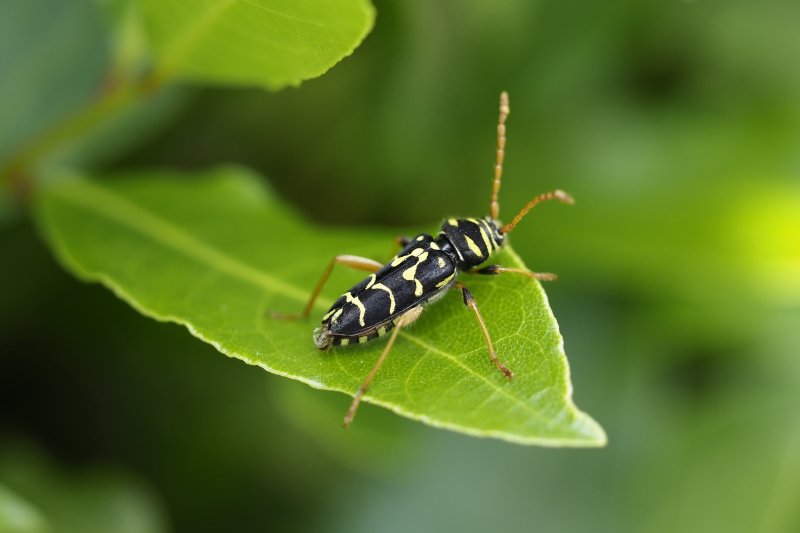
[47,180,564,420]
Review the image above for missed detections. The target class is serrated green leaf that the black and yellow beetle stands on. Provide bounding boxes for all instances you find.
[31,168,605,446]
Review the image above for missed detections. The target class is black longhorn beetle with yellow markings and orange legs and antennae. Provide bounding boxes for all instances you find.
[284,92,574,427]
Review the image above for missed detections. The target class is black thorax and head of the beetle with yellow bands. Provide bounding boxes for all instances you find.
[439,217,504,270]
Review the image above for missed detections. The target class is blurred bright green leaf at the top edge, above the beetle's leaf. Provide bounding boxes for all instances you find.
[141,0,375,89]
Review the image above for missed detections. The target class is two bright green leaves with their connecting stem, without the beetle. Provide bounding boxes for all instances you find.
[0,0,605,458]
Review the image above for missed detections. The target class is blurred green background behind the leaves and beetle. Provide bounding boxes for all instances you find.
[0,0,800,532]
